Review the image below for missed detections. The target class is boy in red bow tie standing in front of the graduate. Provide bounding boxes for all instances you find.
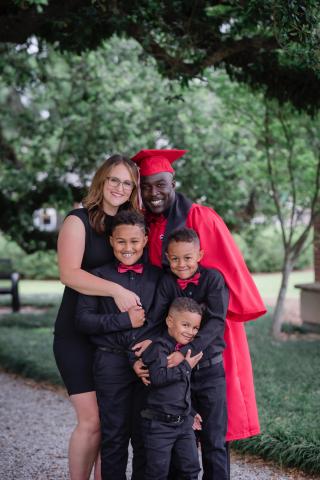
[134,228,229,480]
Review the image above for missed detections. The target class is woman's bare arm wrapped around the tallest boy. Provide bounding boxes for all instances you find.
[58,215,140,312]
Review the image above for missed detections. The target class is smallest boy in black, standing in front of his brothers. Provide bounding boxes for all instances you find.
[141,298,202,480]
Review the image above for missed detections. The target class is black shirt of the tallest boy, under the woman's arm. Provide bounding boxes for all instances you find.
[76,261,163,361]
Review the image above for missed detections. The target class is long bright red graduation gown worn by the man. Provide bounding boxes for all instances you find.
[149,196,266,440]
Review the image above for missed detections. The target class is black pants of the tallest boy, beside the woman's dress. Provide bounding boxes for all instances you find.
[94,350,146,480]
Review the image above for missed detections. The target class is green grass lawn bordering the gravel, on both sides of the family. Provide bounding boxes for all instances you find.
[0,307,320,474]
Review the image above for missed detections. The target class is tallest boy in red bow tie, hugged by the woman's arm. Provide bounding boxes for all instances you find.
[76,211,162,480]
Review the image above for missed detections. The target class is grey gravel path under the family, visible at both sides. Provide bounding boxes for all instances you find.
[0,372,311,480]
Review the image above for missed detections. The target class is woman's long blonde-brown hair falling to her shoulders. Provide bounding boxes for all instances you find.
[82,154,140,233]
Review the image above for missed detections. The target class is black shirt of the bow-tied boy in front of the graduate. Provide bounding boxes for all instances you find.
[152,265,229,361]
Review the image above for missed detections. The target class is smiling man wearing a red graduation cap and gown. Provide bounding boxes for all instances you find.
[132,150,266,441]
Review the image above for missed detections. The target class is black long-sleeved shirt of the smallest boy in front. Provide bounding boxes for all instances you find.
[142,332,191,416]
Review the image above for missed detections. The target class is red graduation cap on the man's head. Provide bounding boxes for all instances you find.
[131,150,187,177]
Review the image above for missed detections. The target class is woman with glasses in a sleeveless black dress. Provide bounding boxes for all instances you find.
[53,155,140,480]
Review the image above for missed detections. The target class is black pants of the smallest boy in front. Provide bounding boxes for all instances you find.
[142,417,200,480]
